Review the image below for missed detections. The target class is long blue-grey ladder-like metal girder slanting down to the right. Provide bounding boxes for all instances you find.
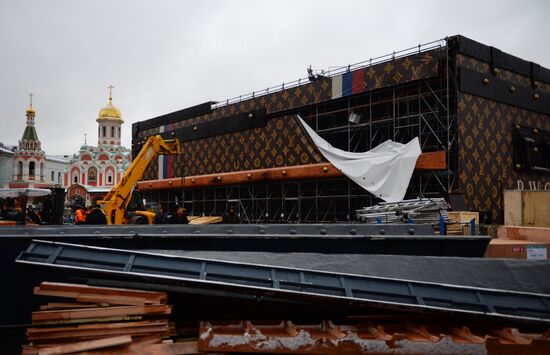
[16,241,550,323]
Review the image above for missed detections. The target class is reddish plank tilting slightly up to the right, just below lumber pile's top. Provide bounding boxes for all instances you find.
[32,305,172,322]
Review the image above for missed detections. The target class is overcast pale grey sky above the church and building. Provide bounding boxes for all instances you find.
[0,0,550,154]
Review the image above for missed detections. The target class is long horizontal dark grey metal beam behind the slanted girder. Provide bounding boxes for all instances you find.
[0,224,490,257]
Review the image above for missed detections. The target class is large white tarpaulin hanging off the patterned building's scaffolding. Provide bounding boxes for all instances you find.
[298,116,421,202]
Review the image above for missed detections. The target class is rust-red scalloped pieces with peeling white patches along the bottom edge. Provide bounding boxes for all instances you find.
[198,320,550,354]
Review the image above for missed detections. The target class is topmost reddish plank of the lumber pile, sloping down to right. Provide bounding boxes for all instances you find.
[39,282,167,303]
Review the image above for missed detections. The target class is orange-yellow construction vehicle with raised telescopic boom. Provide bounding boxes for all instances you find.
[98,135,181,224]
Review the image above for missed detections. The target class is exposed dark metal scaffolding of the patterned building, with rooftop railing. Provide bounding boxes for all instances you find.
[140,39,458,223]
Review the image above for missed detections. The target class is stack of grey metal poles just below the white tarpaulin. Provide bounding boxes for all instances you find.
[356,198,449,224]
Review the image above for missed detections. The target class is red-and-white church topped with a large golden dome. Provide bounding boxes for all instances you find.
[63,86,131,205]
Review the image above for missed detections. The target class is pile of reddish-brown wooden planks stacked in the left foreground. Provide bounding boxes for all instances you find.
[23,282,175,355]
